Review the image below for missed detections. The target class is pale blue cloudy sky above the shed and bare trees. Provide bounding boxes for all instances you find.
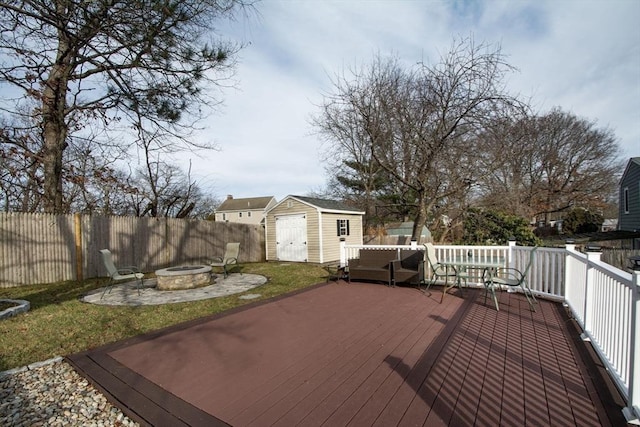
[178,0,640,201]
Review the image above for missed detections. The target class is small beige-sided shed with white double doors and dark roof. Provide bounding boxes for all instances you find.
[265,196,364,264]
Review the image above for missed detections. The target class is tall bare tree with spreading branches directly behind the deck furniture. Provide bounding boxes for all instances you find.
[316,39,520,238]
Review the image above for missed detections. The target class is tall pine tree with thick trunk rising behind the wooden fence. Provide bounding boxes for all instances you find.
[0,0,252,212]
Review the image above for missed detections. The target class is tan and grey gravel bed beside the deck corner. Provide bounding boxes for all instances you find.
[0,358,138,427]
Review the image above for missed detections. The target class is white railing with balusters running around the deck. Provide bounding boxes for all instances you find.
[340,242,640,424]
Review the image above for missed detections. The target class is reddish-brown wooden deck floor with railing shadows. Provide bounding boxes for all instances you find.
[68,282,625,426]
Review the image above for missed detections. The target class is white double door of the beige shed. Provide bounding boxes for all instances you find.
[276,214,307,262]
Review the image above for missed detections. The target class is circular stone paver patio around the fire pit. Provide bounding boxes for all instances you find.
[82,273,267,305]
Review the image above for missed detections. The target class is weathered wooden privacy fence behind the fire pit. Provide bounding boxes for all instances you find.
[0,213,265,287]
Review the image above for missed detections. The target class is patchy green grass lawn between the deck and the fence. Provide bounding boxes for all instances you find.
[0,262,327,371]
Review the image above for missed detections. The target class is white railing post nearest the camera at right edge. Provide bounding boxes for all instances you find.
[622,271,640,425]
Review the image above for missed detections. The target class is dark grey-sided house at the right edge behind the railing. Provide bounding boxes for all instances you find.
[618,157,640,231]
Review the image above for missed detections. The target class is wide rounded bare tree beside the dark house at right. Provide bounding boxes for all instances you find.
[481,108,622,223]
